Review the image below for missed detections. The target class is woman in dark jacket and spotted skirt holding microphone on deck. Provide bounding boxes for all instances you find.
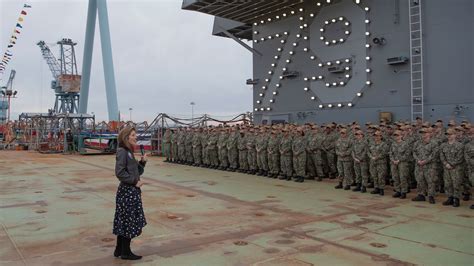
[113,127,147,260]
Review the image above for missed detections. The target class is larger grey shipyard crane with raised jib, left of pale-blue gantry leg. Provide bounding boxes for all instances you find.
[37,38,81,113]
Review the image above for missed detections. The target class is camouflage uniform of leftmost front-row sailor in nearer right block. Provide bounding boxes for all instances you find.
[336,136,354,187]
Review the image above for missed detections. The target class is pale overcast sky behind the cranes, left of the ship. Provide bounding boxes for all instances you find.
[0,0,252,121]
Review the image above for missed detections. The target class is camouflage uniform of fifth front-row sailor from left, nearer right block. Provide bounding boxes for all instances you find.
[413,140,439,197]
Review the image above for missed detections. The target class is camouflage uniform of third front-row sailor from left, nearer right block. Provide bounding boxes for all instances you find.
[368,140,389,190]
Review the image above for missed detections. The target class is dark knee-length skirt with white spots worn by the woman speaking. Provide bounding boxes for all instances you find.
[113,184,146,238]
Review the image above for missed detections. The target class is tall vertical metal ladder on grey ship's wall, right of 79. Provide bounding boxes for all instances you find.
[408,0,424,121]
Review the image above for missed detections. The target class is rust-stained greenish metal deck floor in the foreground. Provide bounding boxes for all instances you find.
[0,151,474,265]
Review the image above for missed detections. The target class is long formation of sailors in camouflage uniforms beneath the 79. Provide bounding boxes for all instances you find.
[163,120,474,208]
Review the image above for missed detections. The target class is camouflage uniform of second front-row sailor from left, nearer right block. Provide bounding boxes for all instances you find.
[352,138,369,187]
